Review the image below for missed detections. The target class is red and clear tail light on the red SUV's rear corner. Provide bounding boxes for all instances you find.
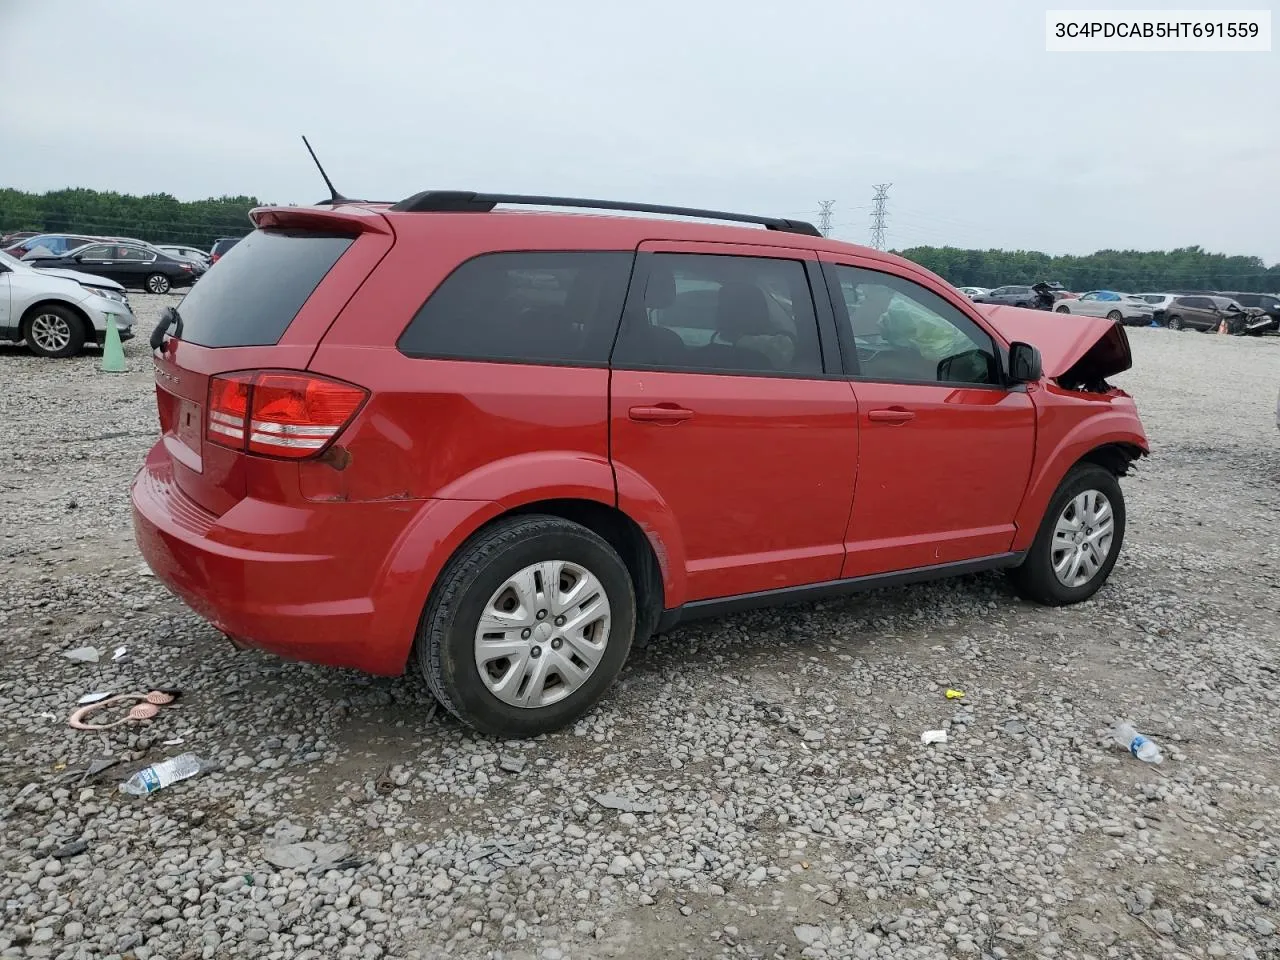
[205,371,369,460]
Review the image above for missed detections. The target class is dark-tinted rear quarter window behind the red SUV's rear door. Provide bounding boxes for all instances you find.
[396,251,635,366]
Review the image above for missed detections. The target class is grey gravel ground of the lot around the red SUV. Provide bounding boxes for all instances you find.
[0,296,1280,960]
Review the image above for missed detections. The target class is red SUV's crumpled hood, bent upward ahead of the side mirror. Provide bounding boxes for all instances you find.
[974,303,1133,380]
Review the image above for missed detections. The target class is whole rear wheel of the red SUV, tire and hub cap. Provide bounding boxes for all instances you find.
[415,515,636,737]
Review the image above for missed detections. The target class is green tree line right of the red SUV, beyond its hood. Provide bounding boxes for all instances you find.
[893,247,1280,293]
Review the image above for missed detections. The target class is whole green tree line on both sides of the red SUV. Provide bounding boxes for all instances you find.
[0,187,1280,293]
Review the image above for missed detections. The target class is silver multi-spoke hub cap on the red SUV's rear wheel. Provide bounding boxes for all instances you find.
[475,561,612,709]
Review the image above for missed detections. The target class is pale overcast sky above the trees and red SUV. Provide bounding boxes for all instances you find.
[0,0,1280,264]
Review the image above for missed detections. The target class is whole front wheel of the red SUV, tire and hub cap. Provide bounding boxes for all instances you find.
[1009,463,1125,607]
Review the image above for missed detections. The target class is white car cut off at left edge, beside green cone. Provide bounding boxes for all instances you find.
[0,252,133,357]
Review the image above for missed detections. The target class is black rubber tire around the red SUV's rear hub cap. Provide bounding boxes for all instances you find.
[415,515,636,739]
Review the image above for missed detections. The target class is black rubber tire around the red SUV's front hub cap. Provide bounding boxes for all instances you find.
[1009,463,1125,607]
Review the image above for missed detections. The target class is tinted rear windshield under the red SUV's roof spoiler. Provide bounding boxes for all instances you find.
[178,230,356,347]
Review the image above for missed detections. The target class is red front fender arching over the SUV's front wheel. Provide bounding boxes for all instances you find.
[1012,398,1149,550]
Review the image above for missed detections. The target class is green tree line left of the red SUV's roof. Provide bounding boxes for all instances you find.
[0,188,262,250]
